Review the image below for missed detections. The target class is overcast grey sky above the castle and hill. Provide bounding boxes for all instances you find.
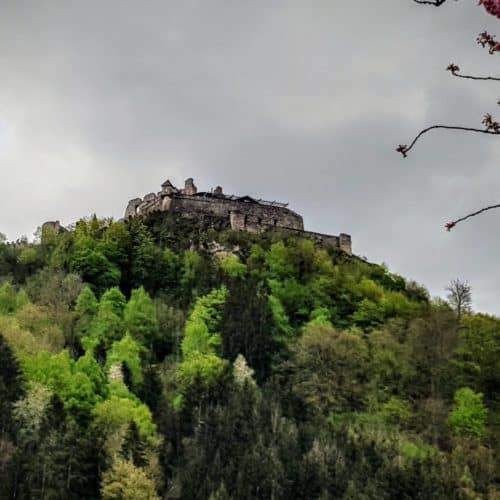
[0,0,500,314]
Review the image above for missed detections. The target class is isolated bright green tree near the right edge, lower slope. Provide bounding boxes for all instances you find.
[448,387,488,438]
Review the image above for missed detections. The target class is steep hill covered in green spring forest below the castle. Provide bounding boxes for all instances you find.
[0,214,500,500]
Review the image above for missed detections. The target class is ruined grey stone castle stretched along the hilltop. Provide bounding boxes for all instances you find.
[125,178,352,255]
